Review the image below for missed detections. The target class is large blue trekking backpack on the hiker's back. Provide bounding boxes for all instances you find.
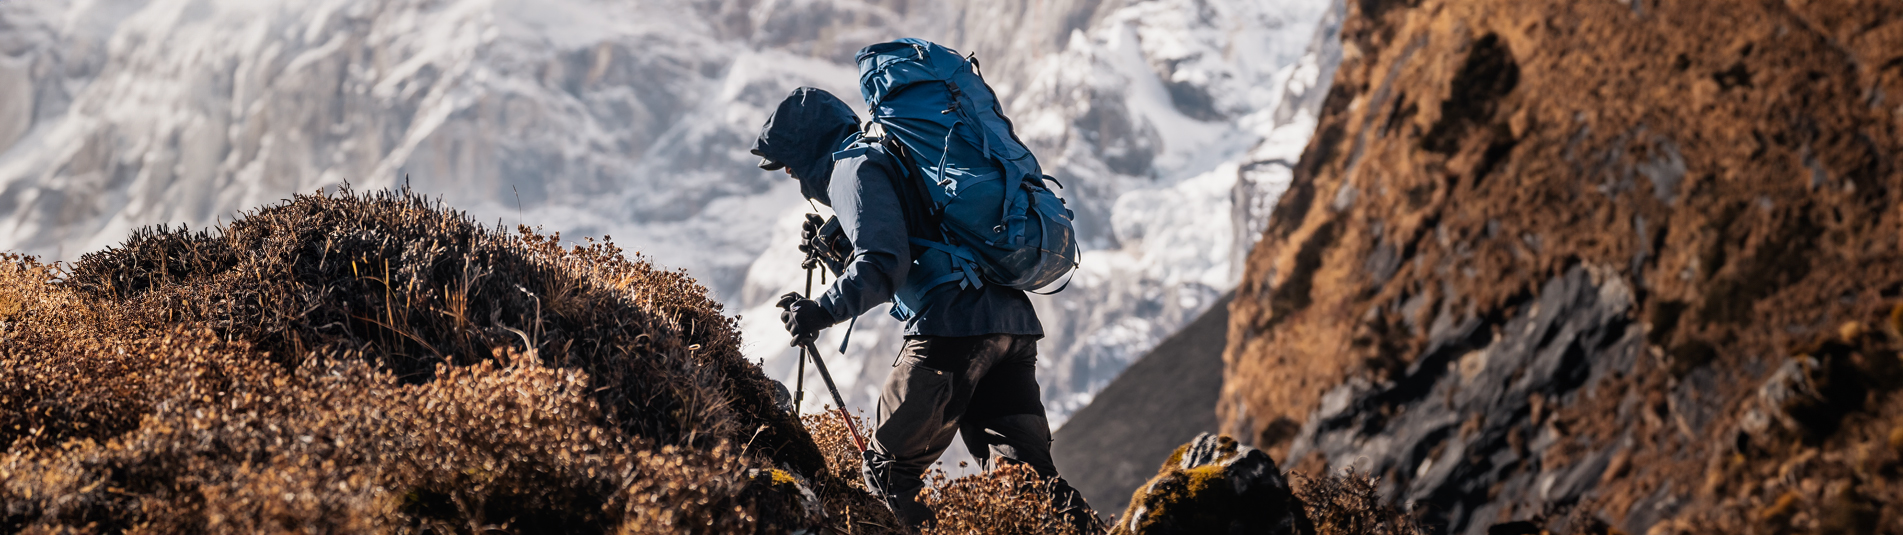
[856,38,1079,293]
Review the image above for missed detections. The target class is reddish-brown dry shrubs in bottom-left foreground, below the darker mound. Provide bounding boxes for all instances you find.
[0,333,799,533]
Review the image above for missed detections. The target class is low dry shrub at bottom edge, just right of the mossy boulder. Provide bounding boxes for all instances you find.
[1288,468,1431,535]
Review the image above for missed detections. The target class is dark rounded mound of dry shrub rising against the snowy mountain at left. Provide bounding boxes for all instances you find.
[63,190,822,462]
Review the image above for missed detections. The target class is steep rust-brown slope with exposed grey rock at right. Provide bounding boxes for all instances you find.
[1218,0,1903,533]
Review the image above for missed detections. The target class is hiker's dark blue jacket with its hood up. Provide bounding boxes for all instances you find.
[754,88,1045,337]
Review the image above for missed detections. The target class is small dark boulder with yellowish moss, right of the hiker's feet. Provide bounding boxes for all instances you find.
[1109,432,1315,535]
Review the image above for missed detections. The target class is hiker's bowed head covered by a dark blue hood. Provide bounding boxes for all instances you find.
[750,88,858,206]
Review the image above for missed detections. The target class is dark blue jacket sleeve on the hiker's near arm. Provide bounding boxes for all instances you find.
[818,149,912,322]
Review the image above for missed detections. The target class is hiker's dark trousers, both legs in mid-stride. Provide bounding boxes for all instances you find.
[864,335,1083,525]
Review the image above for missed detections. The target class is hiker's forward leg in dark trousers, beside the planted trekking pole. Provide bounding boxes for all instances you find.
[862,335,1010,525]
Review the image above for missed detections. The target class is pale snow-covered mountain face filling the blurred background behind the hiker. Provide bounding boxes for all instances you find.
[0,0,1338,437]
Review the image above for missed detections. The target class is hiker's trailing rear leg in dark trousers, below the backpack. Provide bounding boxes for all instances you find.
[959,337,1098,527]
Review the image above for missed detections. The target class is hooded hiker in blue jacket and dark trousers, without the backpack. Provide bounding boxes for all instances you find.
[752,58,1096,527]
